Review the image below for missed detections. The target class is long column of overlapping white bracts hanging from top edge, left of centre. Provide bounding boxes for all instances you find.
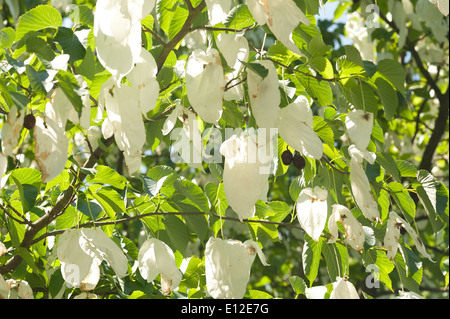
[94,0,159,174]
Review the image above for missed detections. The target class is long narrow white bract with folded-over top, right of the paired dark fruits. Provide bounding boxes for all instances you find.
[348,145,380,221]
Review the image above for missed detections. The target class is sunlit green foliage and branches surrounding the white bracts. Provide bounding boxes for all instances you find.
[0,0,449,298]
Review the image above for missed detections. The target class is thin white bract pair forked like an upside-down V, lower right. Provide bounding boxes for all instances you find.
[384,212,433,261]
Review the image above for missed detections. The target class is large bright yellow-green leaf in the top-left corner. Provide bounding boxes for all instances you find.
[16,5,62,41]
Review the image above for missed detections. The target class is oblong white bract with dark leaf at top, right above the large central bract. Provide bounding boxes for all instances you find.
[247,60,281,128]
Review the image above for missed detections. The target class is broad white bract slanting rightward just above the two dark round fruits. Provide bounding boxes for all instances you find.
[277,95,323,160]
